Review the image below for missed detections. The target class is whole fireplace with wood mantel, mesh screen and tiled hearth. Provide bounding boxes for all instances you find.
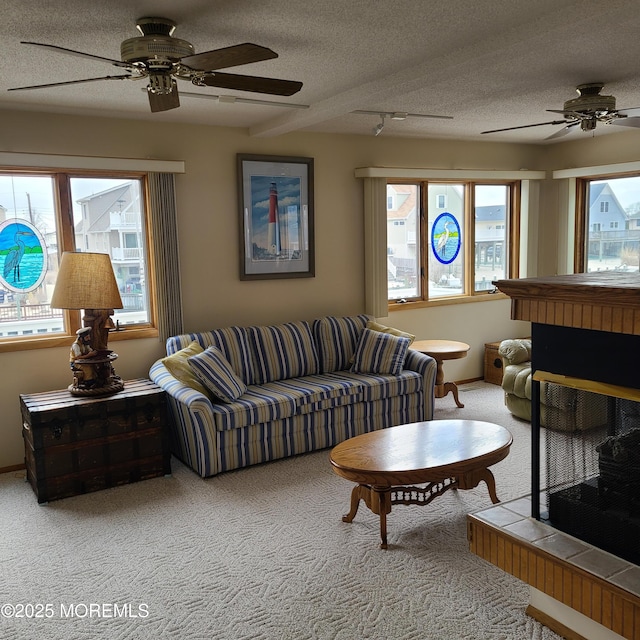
[469,272,640,640]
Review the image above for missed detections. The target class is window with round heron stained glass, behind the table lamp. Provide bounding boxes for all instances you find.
[0,171,153,349]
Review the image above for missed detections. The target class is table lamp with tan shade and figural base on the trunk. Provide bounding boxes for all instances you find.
[51,251,124,396]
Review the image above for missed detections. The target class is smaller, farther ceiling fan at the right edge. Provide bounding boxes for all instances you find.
[482,82,640,140]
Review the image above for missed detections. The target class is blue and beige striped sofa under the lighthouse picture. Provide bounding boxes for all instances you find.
[150,315,436,477]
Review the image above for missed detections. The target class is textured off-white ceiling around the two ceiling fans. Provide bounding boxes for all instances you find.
[0,0,640,144]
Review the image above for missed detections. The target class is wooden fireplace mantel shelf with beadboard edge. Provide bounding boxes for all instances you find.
[493,271,640,335]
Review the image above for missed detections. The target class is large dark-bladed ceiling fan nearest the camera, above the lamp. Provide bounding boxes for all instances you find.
[9,18,302,112]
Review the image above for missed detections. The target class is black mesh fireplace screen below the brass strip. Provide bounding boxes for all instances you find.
[540,382,640,564]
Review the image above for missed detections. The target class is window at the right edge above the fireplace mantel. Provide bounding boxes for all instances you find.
[575,174,640,273]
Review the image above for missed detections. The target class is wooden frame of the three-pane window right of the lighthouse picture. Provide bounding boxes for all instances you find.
[386,178,522,312]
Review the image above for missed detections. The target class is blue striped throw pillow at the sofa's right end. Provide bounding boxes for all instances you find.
[351,329,411,376]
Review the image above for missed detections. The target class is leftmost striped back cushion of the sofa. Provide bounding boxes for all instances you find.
[166,327,254,384]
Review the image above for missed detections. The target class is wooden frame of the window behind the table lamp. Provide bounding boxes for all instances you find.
[0,166,159,353]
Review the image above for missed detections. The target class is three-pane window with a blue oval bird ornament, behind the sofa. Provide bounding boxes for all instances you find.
[387,181,519,302]
